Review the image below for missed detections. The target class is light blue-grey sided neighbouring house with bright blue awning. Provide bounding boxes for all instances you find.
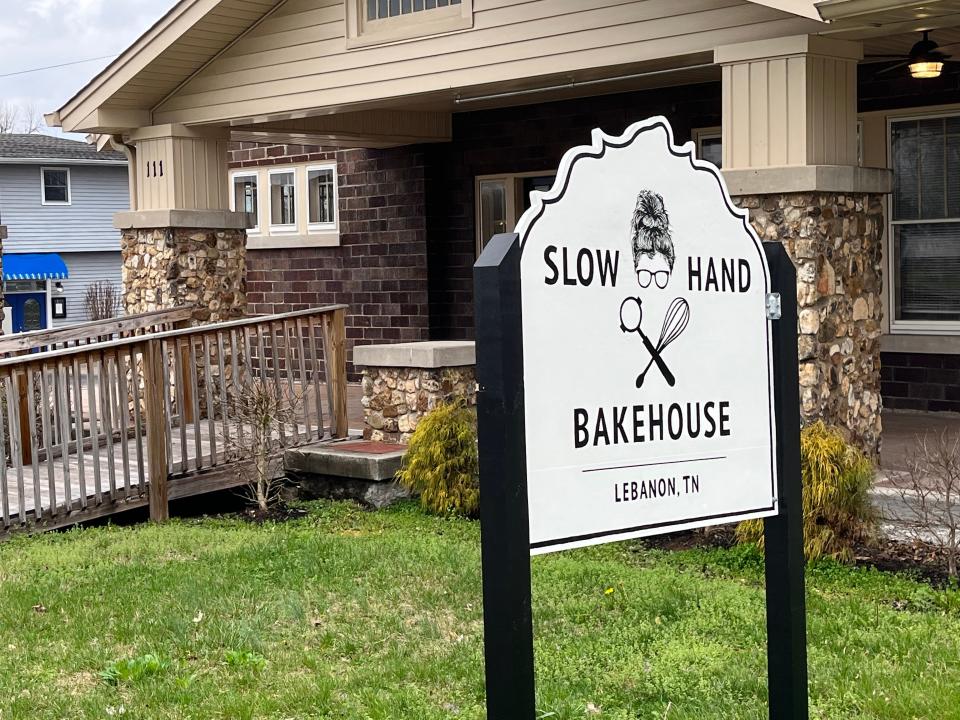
[0,134,130,333]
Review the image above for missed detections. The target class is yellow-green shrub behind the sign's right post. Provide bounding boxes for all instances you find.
[737,422,874,562]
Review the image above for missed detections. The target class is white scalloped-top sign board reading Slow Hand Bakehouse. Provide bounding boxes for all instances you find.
[517,118,777,554]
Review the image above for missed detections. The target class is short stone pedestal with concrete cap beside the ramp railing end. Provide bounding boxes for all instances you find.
[353,341,477,443]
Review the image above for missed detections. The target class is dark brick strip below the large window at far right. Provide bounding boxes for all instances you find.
[880,353,960,412]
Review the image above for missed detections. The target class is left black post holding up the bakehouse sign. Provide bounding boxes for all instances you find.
[473,233,536,720]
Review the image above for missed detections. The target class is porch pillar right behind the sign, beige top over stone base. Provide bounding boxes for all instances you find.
[715,36,890,457]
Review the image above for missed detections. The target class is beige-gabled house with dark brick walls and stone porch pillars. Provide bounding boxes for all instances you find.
[48,0,960,456]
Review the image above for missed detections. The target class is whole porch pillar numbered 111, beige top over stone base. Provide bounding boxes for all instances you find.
[114,125,252,323]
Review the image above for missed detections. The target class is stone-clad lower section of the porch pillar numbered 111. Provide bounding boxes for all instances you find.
[121,228,247,323]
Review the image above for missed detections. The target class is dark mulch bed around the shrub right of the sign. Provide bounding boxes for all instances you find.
[642,525,950,587]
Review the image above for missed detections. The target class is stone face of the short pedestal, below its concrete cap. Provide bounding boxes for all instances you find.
[361,366,477,443]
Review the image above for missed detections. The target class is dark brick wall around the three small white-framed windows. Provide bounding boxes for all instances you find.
[231,144,429,378]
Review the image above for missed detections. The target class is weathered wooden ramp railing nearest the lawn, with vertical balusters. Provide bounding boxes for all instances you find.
[0,305,347,534]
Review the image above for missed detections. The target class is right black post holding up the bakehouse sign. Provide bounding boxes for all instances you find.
[763,243,809,720]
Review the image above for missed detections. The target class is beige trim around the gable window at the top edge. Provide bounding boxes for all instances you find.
[345,0,473,49]
